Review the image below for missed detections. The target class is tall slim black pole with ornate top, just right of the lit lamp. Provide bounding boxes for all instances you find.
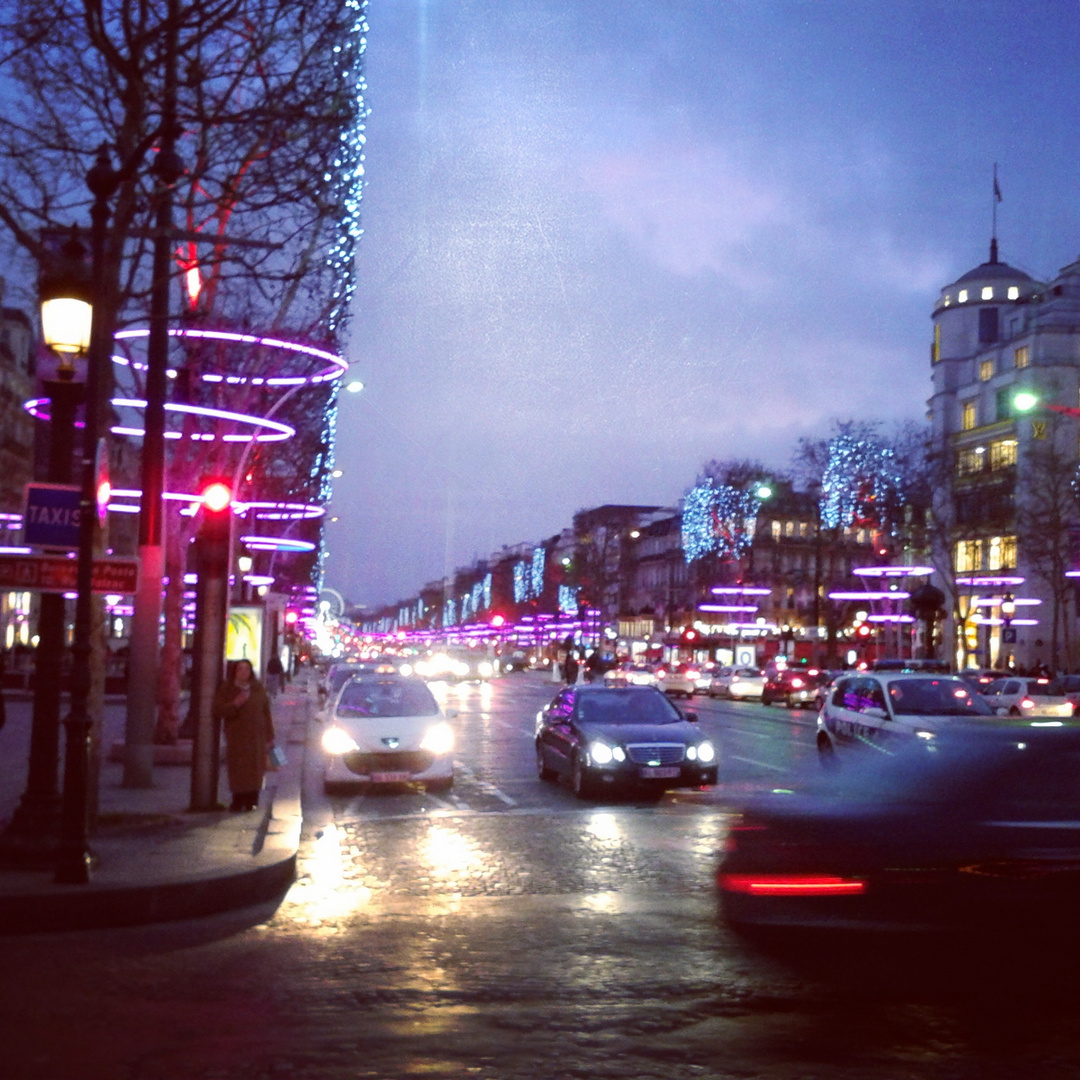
[56,147,117,885]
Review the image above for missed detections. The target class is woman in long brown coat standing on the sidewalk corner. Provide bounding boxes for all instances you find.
[214,660,274,812]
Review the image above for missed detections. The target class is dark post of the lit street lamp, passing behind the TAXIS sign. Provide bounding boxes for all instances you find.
[0,370,83,866]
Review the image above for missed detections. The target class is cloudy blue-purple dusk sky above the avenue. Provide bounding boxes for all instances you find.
[325,0,1080,605]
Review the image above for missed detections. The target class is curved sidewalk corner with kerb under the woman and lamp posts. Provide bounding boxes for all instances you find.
[0,676,312,934]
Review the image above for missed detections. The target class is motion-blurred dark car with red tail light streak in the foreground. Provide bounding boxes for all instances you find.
[717,720,1080,932]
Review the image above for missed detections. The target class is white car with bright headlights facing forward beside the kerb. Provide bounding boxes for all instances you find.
[322,675,457,793]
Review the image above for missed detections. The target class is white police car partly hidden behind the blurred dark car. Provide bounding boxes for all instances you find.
[816,672,994,764]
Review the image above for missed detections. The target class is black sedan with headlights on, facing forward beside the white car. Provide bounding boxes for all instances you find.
[536,686,717,799]
